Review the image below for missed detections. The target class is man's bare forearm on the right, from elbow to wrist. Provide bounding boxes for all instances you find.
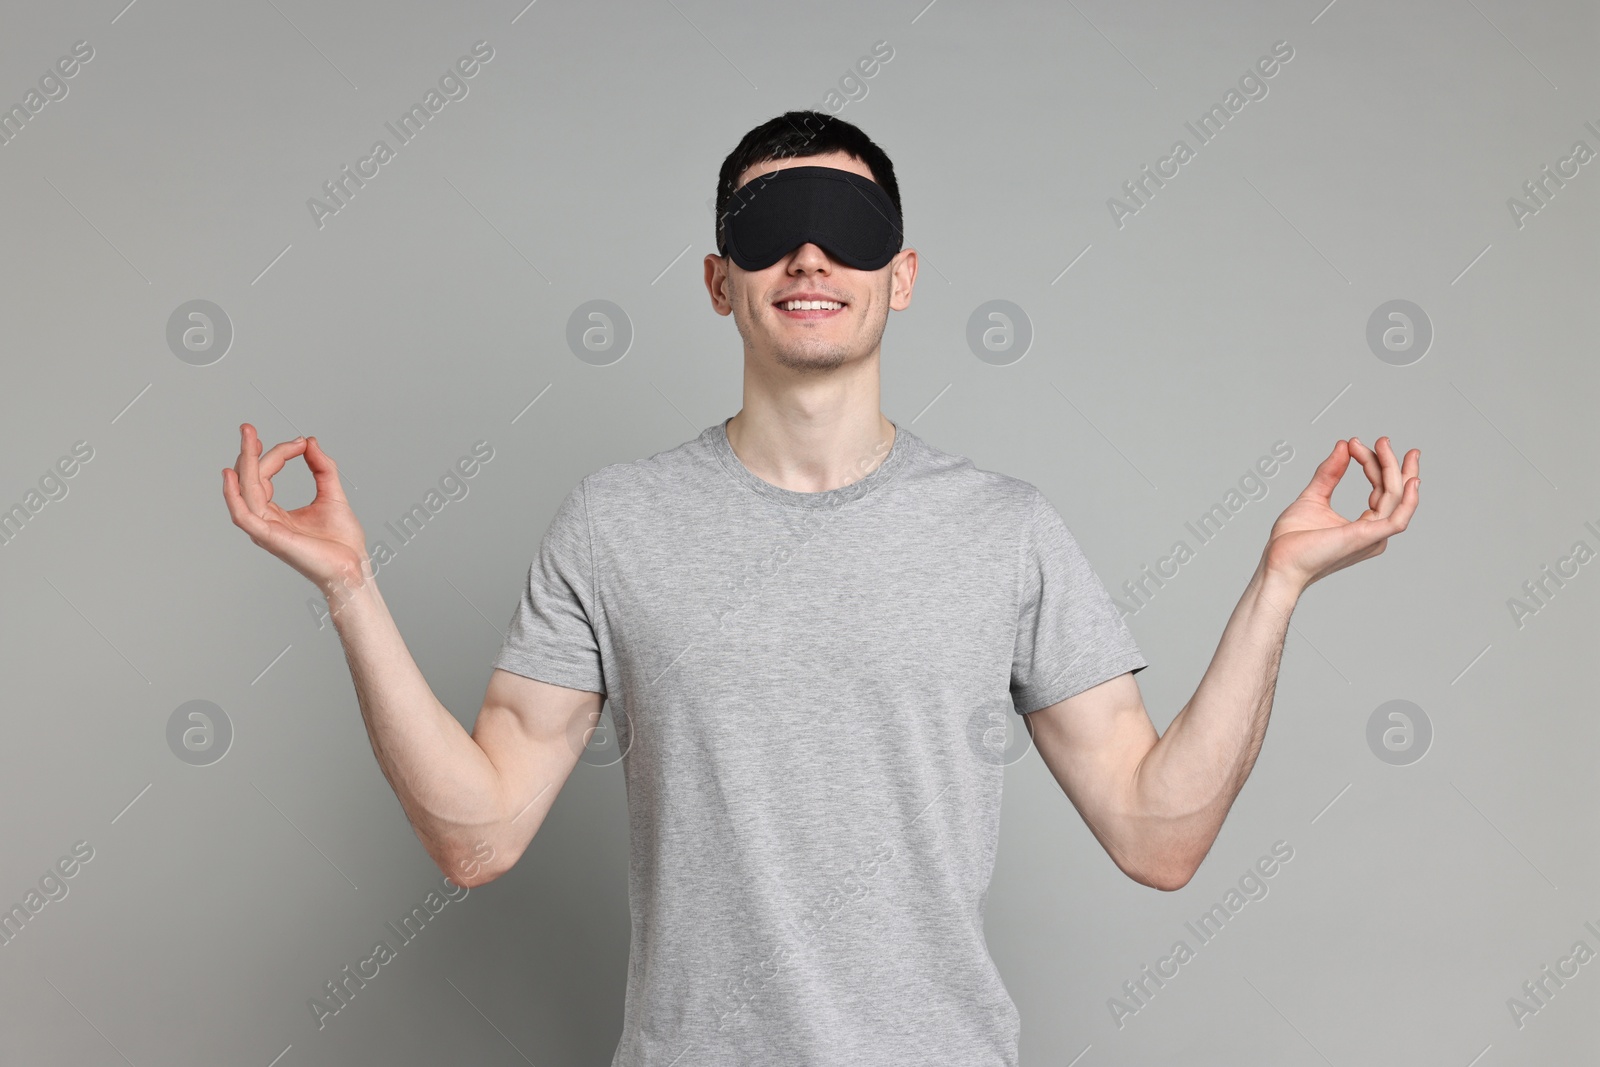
[1131,563,1302,877]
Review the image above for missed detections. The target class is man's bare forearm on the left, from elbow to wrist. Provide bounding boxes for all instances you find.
[328,579,504,878]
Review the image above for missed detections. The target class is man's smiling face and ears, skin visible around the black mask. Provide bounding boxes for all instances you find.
[706,152,917,371]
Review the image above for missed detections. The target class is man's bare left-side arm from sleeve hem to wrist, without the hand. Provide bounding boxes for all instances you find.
[330,581,603,888]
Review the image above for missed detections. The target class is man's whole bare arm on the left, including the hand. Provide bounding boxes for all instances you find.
[222,422,602,888]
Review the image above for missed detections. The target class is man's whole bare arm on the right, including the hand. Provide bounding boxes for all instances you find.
[1027,437,1421,889]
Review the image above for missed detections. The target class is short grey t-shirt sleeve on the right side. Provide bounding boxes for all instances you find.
[1011,491,1149,715]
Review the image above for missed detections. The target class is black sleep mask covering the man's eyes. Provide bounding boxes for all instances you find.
[723,166,901,270]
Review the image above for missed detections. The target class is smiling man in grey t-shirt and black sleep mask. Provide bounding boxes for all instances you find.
[222,112,1421,1067]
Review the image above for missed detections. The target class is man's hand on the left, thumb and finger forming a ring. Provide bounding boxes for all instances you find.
[222,422,366,595]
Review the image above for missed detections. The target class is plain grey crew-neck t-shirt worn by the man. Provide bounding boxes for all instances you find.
[493,422,1146,1067]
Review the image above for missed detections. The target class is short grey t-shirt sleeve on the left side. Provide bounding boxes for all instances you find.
[493,478,605,693]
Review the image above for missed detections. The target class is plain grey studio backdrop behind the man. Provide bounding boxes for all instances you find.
[0,0,1600,1067]
